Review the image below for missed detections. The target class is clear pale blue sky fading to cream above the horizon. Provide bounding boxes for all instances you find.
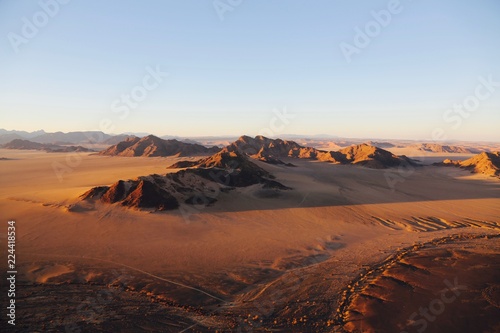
[0,0,500,141]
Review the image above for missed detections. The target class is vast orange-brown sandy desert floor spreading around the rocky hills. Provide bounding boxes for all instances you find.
[0,149,500,332]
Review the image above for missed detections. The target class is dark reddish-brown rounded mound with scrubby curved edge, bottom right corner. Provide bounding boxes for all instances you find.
[337,235,500,332]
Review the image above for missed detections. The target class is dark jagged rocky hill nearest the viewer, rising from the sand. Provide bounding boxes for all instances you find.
[80,149,290,211]
